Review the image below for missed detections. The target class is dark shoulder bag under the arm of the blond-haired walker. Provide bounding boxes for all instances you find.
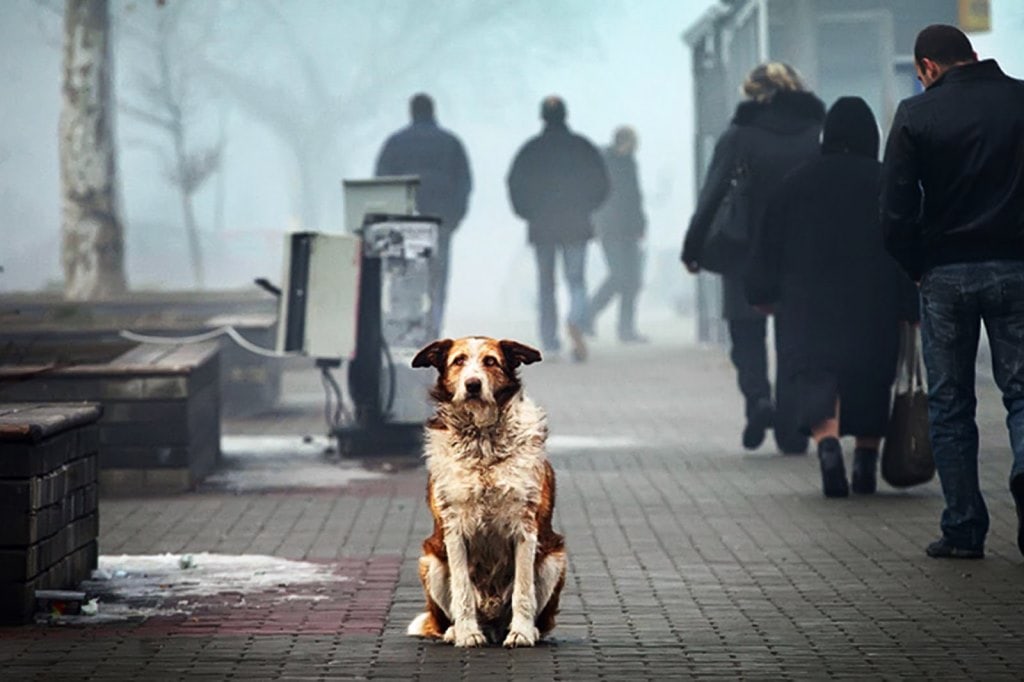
[700,163,751,274]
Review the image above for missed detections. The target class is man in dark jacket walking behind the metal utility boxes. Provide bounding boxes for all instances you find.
[376,93,472,338]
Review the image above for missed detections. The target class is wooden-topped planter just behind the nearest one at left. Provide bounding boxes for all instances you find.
[0,342,220,495]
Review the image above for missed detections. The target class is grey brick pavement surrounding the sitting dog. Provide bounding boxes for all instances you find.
[0,337,1024,680]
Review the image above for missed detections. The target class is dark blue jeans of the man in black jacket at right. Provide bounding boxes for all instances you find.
[921,260,1024,549]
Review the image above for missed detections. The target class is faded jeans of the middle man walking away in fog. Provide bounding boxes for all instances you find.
[534,242,589,351]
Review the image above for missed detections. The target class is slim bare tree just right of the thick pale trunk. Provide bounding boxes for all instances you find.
[121,1,223,289]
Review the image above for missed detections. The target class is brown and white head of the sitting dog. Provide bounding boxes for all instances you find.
[413,336,541,421]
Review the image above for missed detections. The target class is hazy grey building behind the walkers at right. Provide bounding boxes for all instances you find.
[683,0,991,342]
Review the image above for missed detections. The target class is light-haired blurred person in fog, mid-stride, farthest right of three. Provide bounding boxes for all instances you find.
[587,126,647,343]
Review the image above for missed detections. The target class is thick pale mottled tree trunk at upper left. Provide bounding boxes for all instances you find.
[59,0,126,301]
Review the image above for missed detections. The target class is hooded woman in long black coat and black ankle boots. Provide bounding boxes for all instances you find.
[746,97,916,497]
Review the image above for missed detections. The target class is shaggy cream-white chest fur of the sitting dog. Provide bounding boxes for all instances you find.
[426,396,547,536]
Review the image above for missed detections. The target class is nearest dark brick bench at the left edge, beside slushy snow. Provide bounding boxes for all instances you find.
[0,402,100,624]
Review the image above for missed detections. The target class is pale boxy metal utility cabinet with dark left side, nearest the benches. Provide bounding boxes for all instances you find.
[278,232,361,359]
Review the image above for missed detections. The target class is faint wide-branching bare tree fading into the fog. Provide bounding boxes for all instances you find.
[206,0,589,228]
